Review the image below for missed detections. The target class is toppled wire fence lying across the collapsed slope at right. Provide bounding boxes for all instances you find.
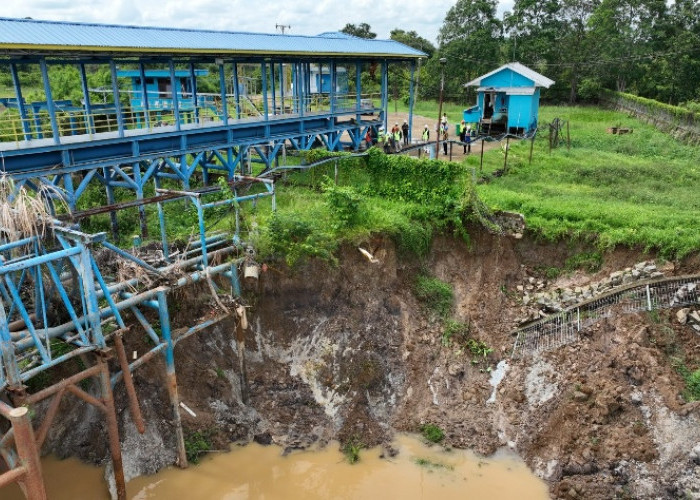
[511,276,700,358]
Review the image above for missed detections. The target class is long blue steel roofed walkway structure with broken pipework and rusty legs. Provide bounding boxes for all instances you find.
[0,18,424,499]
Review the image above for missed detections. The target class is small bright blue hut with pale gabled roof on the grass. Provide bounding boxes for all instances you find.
[464,62,554,135]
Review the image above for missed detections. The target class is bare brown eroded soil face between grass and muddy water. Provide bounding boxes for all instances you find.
[45,230,700,499]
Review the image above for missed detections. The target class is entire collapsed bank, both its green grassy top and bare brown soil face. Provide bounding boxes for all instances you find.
[31,103,700,499]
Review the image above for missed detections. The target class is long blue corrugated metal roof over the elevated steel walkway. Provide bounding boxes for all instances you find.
[0,18,426,58]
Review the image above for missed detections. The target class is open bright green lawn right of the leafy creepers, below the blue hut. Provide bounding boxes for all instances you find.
[467,107,700,257]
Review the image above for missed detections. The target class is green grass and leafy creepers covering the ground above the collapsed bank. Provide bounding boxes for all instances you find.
[72,97,700,264]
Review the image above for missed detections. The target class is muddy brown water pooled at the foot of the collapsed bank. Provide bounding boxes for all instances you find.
[2,436,549,500]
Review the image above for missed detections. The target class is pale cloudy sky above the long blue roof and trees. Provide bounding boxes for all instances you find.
[0,0,513,43]
